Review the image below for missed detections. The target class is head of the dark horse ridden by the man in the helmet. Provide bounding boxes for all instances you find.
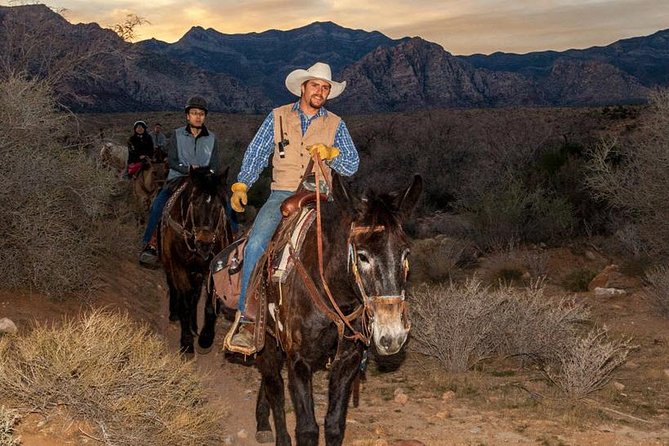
[184,167,229,260]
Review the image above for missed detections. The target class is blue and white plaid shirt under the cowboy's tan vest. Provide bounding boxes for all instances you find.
[237,101,360,188]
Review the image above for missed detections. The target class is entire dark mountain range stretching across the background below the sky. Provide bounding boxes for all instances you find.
[0,5,669,113]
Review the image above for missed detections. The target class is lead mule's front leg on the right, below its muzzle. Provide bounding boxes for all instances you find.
[325,347,362,446]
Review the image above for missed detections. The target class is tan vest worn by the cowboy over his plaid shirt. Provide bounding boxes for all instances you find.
[271,104,341,191]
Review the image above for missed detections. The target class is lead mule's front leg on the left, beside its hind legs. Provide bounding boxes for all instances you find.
[288,357,318,446]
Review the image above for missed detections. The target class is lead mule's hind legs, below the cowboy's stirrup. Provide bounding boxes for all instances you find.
[256,338,291,446]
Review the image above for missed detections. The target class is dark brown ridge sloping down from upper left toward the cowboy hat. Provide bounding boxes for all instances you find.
[0,5,271,113]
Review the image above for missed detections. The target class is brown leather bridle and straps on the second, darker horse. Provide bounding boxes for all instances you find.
[166,181,228,260]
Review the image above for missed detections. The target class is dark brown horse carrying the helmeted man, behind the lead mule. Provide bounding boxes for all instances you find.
[160,167,232,353]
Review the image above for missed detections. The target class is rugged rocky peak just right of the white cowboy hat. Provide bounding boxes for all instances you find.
[336,38,547,113]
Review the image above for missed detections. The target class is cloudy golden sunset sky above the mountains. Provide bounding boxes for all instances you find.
[6,0,669,55]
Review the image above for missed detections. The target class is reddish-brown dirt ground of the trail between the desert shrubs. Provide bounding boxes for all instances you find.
[0,254,669,446]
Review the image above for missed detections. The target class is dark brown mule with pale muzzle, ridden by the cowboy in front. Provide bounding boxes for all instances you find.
[256,175,423,446]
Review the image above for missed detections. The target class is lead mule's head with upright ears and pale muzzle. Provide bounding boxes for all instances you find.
[333,175,423,355]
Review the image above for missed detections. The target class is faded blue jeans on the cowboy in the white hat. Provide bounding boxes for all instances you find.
[238,190,293,313]
